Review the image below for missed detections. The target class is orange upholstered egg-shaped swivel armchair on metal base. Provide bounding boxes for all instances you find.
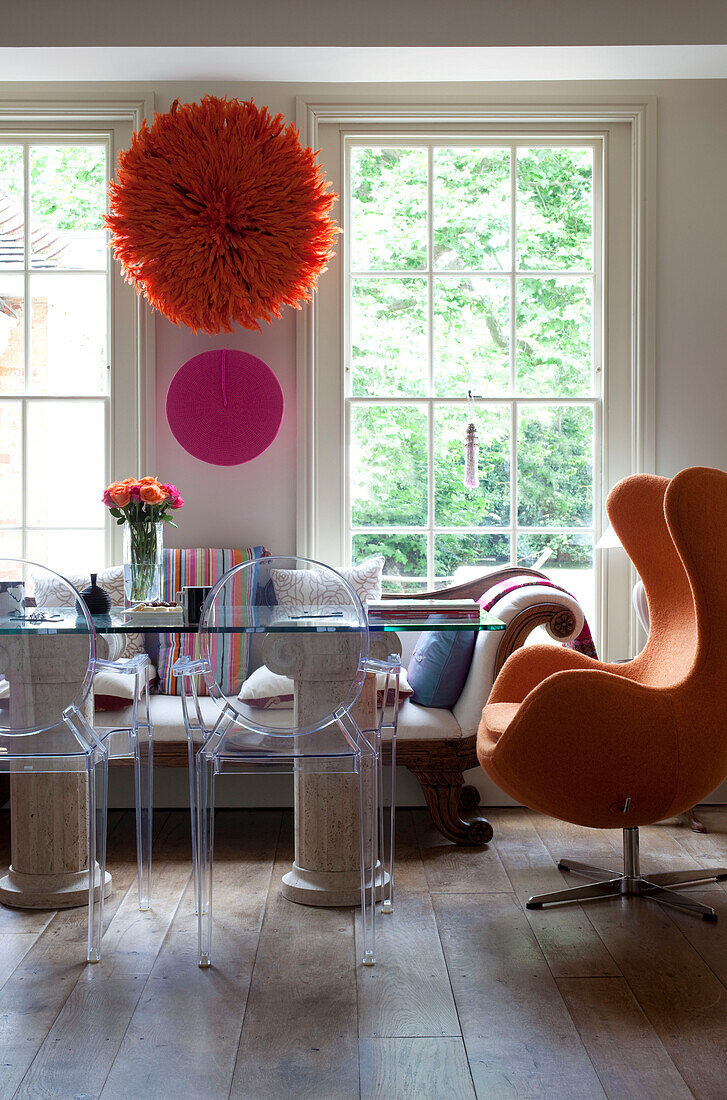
[477,468,727,920]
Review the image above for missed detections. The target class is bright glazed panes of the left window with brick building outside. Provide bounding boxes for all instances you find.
[0,135,109,572]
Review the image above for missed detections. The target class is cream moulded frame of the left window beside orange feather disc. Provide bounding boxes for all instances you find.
[0,89,155,564]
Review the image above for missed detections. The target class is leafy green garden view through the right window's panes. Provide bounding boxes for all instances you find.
[345,139,602,611]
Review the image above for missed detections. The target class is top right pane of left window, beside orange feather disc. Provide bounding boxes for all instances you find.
[30,145,108,270]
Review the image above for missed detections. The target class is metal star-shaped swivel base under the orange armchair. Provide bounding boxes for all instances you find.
[526,827,727,921]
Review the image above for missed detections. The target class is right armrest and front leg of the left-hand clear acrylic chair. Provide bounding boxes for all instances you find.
[93,653,154,912]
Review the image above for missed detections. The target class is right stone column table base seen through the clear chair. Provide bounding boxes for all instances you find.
[265,631,399,906]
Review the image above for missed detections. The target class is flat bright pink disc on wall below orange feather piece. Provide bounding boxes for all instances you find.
[166,349,284,466]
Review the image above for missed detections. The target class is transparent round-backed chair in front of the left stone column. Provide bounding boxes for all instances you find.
[0,559,108,963]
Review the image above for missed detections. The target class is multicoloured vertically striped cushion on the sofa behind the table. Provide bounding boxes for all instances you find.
[157,547,267,695]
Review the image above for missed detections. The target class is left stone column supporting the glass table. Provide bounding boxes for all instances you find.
[0,635,111,909]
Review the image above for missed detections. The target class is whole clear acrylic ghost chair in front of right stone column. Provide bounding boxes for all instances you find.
[174,558,387,967]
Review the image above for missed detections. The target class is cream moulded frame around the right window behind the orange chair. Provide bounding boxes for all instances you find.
[297,94,656,659]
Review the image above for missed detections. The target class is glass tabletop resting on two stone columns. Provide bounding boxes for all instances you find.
[0,606,505,635]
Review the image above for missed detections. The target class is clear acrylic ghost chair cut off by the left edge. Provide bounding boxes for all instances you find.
[0,559,107,961]
